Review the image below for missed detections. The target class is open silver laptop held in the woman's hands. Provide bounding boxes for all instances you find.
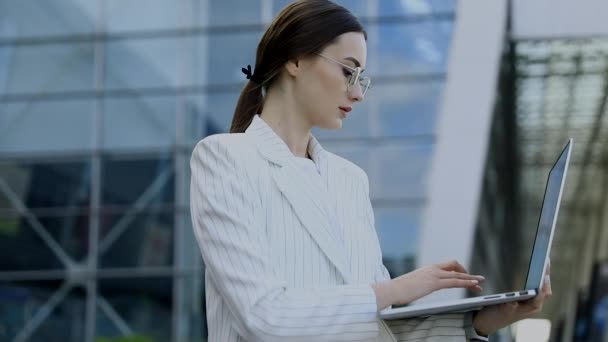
[380,138,572,320]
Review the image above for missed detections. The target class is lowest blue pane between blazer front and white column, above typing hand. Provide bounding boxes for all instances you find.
[374,207,422,276]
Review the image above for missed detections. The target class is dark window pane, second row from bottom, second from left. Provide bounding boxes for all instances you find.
[99,209,174,268]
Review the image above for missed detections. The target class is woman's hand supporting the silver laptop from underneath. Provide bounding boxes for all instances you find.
[473,264,552,336]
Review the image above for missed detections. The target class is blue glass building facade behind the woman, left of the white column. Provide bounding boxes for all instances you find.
[0,0,456,341]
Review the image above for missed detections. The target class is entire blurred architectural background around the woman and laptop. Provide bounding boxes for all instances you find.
[0,0,608,342]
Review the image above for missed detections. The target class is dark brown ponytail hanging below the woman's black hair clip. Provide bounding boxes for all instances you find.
[230,80,264,133]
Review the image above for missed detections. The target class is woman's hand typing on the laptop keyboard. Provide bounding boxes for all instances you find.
[372,260,485,310]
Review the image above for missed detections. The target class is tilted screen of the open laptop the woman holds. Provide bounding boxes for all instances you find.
[525,141,571,289]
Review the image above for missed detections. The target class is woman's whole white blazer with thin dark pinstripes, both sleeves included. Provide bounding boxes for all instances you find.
[190,115,476,342]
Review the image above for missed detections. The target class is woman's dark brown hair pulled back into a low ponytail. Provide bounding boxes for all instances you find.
[230,0,367,133]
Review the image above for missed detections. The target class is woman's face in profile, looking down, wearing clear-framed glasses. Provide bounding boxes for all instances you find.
[295,32,367,129]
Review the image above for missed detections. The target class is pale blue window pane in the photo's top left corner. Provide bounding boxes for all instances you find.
[0,0,97,38]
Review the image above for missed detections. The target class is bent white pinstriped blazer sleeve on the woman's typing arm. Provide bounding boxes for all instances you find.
[190,136,379,341]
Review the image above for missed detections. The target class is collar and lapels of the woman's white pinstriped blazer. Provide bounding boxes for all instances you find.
[246,115,352,283]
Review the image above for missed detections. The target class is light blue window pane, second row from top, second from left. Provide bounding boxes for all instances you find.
[105,38,186,88]
